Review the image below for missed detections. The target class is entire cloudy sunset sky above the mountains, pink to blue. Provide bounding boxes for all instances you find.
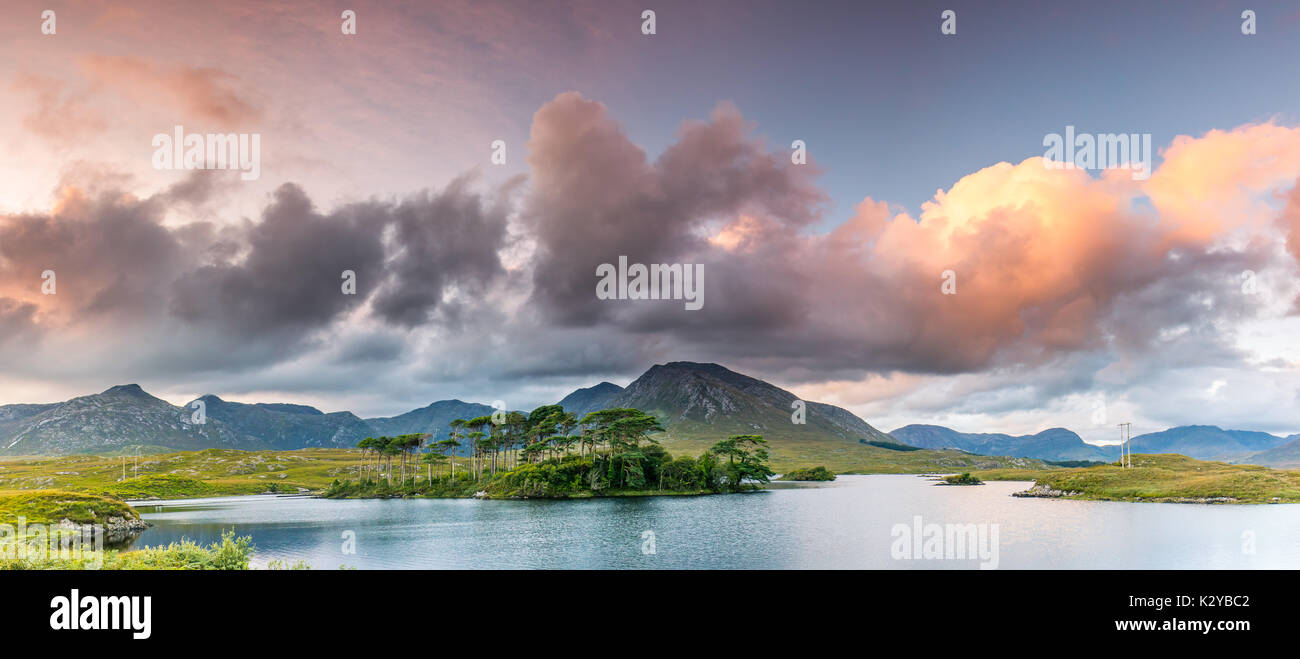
[0,0,1300,442]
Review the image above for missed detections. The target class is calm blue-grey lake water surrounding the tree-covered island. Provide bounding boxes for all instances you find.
[126,476,1300,569]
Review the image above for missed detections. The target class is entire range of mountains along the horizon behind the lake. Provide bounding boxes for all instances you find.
[0,361,1300,467]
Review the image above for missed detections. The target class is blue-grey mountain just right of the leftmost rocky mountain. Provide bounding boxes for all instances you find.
[186,394,374,450]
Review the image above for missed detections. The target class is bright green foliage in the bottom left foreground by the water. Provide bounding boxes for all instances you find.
[0,530,276,569]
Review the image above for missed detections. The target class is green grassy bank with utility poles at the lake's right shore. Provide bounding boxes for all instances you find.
[974,454,1300,503]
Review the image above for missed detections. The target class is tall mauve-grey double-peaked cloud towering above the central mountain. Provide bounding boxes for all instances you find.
[524,92,824,325]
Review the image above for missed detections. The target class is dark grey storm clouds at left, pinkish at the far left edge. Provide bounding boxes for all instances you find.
[0,173,517,369]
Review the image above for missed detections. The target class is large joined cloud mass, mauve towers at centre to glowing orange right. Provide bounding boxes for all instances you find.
[514,94,1300,392]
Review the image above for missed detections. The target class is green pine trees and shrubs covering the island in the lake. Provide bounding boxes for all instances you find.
[324,406,775,498]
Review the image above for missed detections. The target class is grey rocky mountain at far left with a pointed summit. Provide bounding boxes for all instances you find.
[0,385,267,455]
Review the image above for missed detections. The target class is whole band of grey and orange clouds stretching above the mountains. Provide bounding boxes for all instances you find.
[0,92,1300,432]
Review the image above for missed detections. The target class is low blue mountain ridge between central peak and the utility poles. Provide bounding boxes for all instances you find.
[889,424,1119,461]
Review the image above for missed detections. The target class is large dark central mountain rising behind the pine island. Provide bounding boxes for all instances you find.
[562,361,889,445]
